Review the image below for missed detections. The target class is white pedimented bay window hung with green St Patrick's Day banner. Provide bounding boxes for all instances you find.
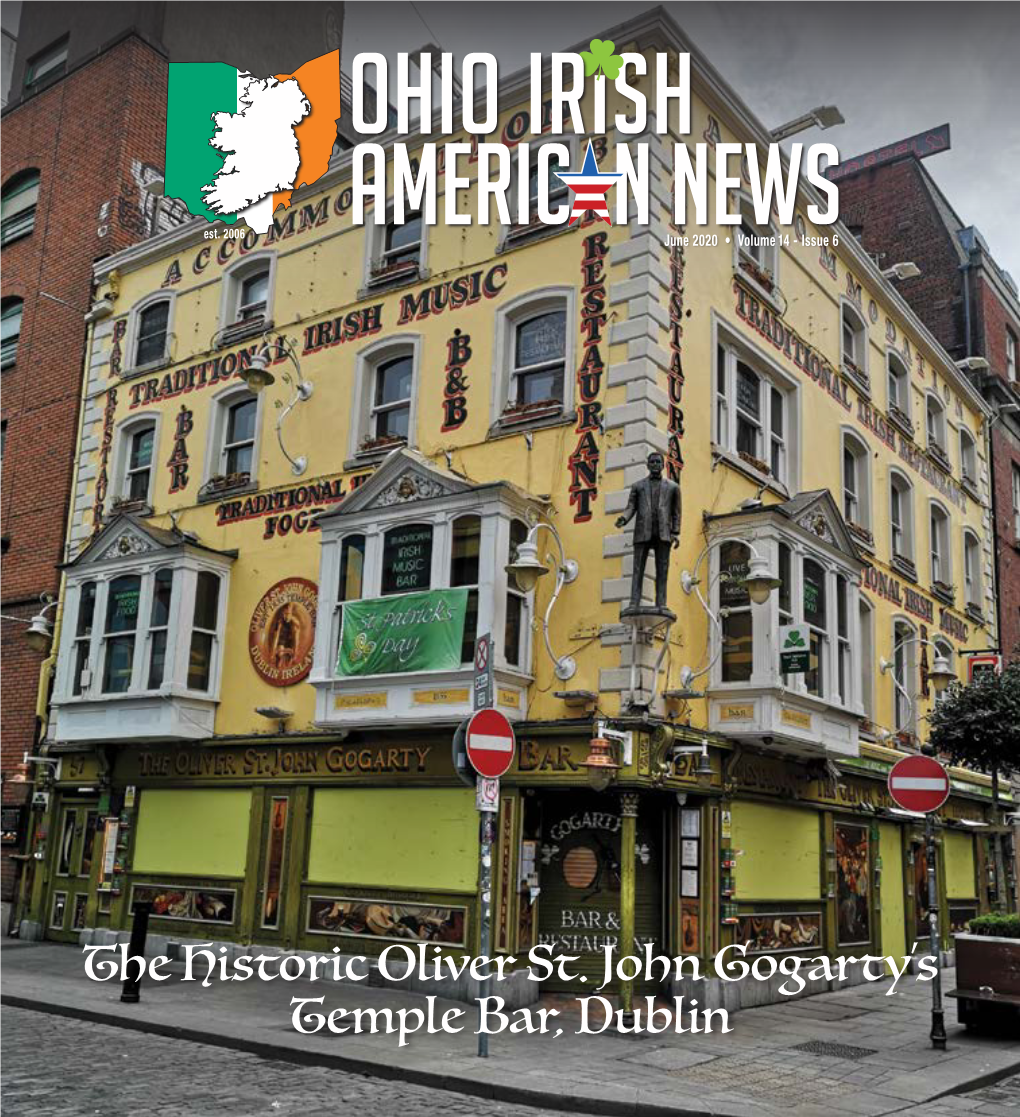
[311,449,531,726]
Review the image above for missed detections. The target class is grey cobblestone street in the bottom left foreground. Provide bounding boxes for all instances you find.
[0,1008,585,1117]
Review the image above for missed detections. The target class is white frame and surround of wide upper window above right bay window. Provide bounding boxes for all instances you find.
[712,322,800,495]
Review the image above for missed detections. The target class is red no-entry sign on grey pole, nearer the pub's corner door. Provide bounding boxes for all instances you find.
[465,705,516,1059]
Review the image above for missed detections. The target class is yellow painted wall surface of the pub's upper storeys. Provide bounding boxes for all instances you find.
[67,37,994,734]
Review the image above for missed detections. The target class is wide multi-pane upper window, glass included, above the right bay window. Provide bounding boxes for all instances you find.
[715,344,793,485]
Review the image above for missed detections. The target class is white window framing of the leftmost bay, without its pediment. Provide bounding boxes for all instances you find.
[54,553,230,705]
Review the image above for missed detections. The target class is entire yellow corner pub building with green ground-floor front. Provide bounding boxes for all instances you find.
[21,11,998,1005]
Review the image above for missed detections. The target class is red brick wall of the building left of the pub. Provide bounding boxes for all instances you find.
[0,37,166,899]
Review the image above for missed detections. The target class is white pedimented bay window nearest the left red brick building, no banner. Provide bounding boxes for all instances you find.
[54,516,232,741]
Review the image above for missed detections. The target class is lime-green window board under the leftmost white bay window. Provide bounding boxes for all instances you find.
[132,787,251,877]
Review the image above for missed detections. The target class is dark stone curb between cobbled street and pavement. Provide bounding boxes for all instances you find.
[0,993,710,1117]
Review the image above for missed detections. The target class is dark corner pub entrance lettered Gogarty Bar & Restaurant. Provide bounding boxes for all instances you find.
[537,791,664,993]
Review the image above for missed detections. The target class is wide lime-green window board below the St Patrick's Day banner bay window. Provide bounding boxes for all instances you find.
[308,787,478,891]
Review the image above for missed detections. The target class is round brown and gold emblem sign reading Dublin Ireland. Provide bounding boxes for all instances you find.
[248,577,318,687]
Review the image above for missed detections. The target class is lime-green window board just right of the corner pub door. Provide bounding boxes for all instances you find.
[733,802,821,900]
